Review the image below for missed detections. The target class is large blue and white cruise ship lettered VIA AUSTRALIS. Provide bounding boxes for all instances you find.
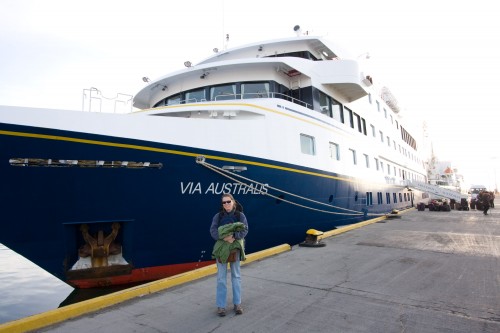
[0,27,427,288]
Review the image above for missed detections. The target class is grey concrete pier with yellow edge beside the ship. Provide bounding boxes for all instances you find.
[0,202,500,333]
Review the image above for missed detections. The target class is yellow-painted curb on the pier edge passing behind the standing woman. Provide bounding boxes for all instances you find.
[0,244,291,333]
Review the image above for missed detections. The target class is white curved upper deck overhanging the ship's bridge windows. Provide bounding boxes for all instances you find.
[134,36,371,109]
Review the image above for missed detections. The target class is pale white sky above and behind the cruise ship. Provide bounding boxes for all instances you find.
[0,0,500,189]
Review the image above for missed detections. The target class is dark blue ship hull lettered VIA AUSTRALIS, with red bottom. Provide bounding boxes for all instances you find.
[0,124,410,287]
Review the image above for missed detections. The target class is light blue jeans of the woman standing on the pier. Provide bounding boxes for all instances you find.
[216,255,241,308]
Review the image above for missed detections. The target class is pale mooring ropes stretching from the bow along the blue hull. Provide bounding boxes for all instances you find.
[196,156,385,216]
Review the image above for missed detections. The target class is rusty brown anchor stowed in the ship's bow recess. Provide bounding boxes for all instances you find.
[78,222,121,268]
